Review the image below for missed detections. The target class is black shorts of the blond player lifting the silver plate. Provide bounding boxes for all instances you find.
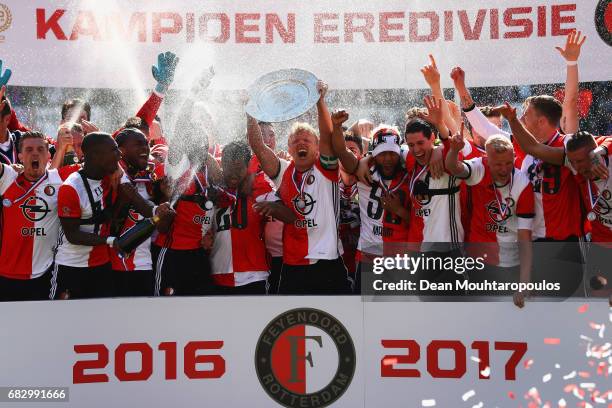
[278,258,351,295]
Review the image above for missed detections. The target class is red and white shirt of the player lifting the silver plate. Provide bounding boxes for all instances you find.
[273,158,342,265]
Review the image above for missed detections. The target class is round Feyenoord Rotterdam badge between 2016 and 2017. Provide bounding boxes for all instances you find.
[255,308,356,408]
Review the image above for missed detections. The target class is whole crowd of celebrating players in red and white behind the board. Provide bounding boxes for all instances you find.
[0,32,612,305]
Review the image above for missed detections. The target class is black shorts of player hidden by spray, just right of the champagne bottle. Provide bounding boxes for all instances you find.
[151,245,215,296]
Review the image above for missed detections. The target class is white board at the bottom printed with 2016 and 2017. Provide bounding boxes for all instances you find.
[0,297,612,408]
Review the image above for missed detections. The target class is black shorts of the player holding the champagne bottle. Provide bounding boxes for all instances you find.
[50,263,113,299]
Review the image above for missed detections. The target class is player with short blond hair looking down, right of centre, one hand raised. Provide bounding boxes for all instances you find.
[446,126,535,307]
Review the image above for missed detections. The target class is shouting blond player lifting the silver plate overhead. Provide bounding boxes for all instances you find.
[248,82,349,294]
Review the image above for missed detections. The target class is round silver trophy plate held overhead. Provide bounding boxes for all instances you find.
[246,69,319,122]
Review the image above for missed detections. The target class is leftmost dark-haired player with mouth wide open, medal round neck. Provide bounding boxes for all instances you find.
[0,131,78,301]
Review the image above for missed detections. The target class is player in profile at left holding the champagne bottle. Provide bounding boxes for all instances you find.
[51,132,171,299]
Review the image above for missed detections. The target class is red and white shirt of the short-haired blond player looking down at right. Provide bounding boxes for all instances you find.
[465,158,535,267]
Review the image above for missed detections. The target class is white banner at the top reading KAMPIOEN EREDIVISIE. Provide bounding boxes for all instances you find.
[0,0,612,89]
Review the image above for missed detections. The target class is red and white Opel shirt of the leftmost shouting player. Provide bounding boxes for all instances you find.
[0,164,79,279]
